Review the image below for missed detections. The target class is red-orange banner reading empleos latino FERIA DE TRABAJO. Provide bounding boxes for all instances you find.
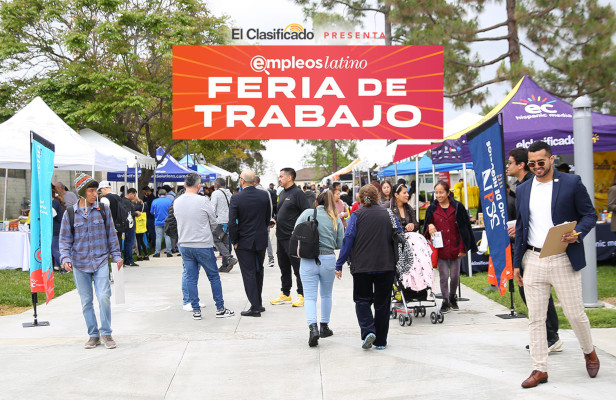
[173,46,443,139]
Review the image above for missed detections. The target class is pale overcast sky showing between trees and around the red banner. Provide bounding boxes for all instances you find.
[208,0,527,183]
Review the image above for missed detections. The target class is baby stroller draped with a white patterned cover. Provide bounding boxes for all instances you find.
[391,232,445,326]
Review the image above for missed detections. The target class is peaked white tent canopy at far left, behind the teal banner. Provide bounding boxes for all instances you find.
[0,97,126,171]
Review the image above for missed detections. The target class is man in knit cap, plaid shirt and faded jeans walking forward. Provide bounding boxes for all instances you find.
[60,174,123,349]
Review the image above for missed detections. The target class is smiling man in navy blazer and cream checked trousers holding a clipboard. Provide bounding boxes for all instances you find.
[513,141,599,388]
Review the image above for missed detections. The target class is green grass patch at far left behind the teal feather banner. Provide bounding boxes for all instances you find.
[0,269,75,307]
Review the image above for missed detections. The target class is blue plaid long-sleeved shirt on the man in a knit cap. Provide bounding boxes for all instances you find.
[60,203,122,272]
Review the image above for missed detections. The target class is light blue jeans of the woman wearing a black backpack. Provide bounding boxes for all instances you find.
[299,254,336,325]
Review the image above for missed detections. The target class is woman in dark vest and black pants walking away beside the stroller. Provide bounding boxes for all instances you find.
[336,184,401,350]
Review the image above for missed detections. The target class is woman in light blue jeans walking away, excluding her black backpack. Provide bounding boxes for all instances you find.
[295,190,344,347]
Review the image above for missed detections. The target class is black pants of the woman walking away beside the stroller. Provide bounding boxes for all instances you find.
[353,271,394,346]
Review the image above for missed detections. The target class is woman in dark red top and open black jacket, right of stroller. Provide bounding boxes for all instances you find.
[424,180,477,313]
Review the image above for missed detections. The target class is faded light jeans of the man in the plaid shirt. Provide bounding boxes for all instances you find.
[73,263,111,337]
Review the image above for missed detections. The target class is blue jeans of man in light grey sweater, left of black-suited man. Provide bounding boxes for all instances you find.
[178,246,225,311]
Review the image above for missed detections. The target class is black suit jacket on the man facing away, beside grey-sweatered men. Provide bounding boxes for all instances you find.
[229,186,272,250]
